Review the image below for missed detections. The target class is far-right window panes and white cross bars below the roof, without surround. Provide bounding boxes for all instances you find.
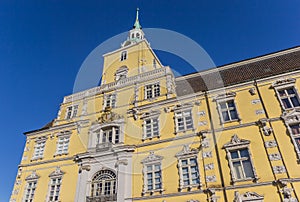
[278,87,300,109]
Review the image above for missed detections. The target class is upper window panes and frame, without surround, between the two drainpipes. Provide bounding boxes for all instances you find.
[219,100,238,122]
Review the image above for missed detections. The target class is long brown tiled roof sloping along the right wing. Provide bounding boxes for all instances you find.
[176,46,300,96]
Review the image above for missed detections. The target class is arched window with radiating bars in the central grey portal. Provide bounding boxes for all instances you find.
[91,170,117,198]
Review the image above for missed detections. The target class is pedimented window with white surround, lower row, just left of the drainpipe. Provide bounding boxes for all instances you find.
[175,145,201,190]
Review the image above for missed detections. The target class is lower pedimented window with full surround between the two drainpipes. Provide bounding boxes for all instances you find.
[224,135,258,182]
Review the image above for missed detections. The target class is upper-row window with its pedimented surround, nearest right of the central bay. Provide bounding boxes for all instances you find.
[141,110,160,140]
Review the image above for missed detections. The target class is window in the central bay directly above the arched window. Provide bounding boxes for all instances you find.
[98,126,120,144]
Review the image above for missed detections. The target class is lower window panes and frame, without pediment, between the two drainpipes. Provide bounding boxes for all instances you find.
[230,148,254,180]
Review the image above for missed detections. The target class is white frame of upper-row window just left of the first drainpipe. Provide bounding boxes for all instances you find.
[174,108,195,133]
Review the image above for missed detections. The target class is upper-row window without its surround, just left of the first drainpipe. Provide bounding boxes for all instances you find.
[175,110,193,132]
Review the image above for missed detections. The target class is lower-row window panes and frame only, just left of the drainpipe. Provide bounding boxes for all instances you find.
[179,158,200,186]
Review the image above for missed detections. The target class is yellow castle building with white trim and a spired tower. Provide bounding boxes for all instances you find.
[10,9,300,202]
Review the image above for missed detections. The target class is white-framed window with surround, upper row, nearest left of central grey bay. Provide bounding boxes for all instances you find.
[54,131,72,156]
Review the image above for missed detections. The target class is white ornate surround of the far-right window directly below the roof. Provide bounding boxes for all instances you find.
[272,78,300,110]
